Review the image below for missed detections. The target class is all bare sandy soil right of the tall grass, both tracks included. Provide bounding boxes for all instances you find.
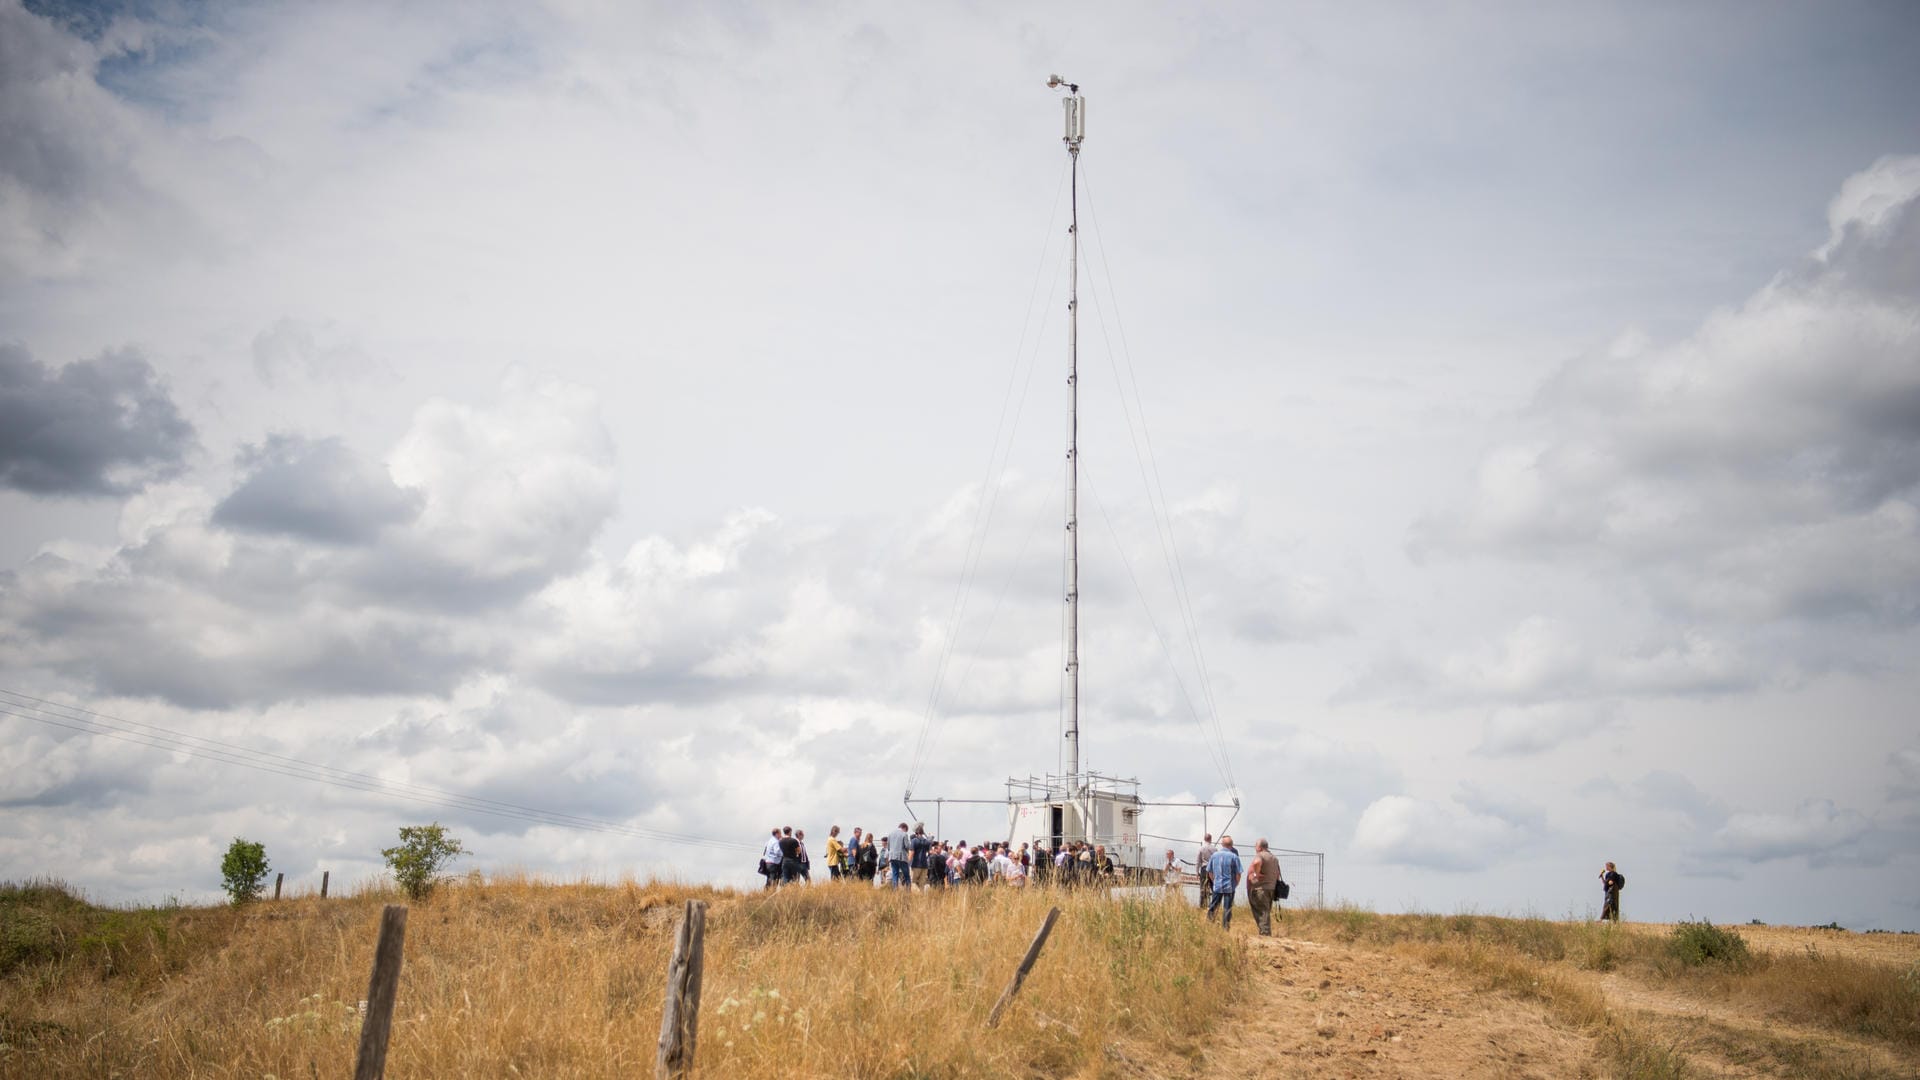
[1152,910,1920,1080]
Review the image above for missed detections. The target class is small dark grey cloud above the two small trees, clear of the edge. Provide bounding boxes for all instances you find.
[213,434,422,544]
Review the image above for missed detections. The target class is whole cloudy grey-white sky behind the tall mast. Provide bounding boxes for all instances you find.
[0,0,1920,928]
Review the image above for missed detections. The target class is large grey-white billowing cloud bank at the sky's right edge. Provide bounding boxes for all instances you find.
[1411,158,1920,625]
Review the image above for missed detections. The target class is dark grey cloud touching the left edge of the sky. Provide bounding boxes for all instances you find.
[0,344,194,496]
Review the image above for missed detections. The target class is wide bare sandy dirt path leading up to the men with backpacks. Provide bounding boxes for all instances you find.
[1156,938,1603,1080]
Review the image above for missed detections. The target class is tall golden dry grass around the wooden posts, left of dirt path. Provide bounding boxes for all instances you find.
[0,878,1242,1080]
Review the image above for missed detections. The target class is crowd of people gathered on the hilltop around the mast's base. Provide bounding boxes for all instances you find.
[760,821,1286,934]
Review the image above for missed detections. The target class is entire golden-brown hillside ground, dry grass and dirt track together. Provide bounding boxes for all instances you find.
[0,878,1920,1080]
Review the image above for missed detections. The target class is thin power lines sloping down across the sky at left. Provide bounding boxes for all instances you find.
[0,688,760,851]
